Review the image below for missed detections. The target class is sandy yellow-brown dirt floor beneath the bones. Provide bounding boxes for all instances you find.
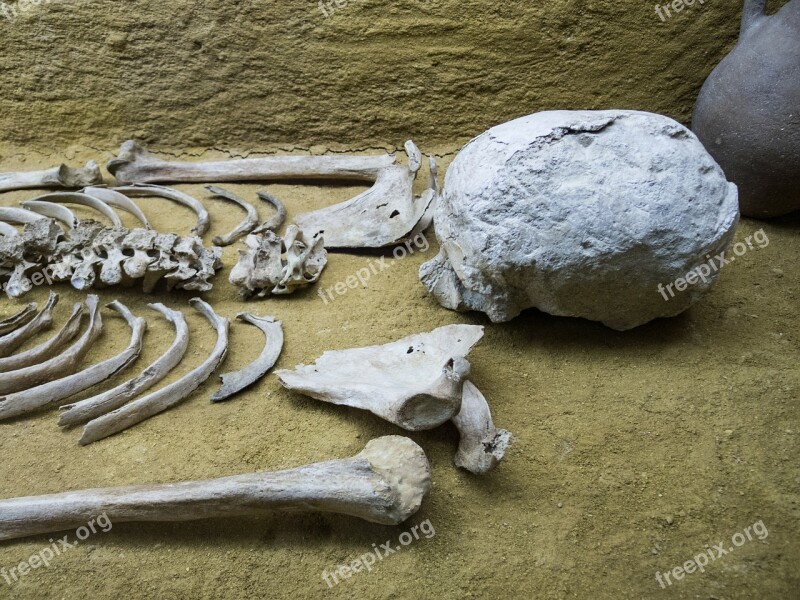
[0,148,800,600]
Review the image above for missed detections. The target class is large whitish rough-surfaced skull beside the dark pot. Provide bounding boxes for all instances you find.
[420,110,739,330]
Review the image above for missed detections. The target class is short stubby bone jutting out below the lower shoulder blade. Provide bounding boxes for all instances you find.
[453,381,511,475]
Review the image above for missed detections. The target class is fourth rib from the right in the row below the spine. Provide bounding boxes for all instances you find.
[0,300,147,421]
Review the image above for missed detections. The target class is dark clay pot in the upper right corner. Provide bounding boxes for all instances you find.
[692,0,800,217]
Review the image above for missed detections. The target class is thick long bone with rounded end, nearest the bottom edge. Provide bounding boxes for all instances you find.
[0,436,431,540]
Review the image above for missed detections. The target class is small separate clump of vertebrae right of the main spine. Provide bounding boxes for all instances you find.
[230,225,328,298]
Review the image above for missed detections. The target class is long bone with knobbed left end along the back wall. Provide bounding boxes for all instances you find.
[107,140,395,185]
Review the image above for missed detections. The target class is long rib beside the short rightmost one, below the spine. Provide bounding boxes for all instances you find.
[80,298,229,445]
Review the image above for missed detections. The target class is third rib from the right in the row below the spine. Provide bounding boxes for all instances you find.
[58,304,189,427]
